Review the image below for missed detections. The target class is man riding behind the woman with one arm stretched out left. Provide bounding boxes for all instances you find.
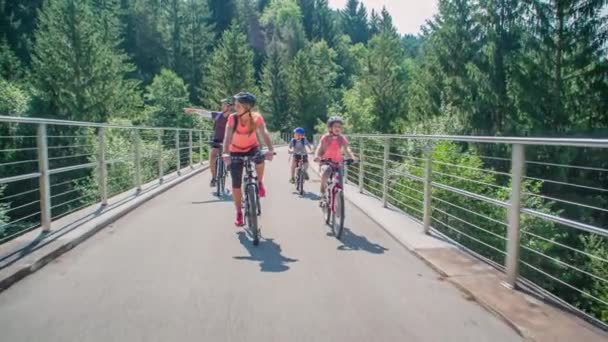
[184,98,234,187]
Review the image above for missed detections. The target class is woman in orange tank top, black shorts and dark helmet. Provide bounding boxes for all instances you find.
[223,92,274,227]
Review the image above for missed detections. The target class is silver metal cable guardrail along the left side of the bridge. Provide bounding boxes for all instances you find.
[0,116,217,243]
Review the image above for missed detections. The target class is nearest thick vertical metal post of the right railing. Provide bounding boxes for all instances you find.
[505,144,525,288]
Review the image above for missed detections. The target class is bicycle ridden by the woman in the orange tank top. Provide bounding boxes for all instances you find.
[232,152,276,246]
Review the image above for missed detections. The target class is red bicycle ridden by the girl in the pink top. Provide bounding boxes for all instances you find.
[321,159,354,240]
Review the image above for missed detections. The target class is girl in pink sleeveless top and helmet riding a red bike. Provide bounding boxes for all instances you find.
[315,116,356,205]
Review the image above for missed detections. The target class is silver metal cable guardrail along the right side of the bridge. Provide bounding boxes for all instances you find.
[315,134,608,328]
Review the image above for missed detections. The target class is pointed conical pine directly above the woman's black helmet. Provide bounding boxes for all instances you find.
[205,23,255,105]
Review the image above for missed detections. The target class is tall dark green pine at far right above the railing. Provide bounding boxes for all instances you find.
[514,0,608,132]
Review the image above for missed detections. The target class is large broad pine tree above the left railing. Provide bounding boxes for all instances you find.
[32,0,139,122]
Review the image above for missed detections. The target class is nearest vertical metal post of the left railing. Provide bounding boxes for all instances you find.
[36,124,51,232]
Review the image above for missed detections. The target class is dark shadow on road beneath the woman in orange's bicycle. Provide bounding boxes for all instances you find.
[234,232,298,272]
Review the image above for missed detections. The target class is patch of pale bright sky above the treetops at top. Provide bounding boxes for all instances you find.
[329,0,437,34]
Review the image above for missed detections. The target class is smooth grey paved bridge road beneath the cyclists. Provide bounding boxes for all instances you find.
[0,151,521,342]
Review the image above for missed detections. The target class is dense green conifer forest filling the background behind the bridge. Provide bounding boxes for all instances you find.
[0,0,608,322]
